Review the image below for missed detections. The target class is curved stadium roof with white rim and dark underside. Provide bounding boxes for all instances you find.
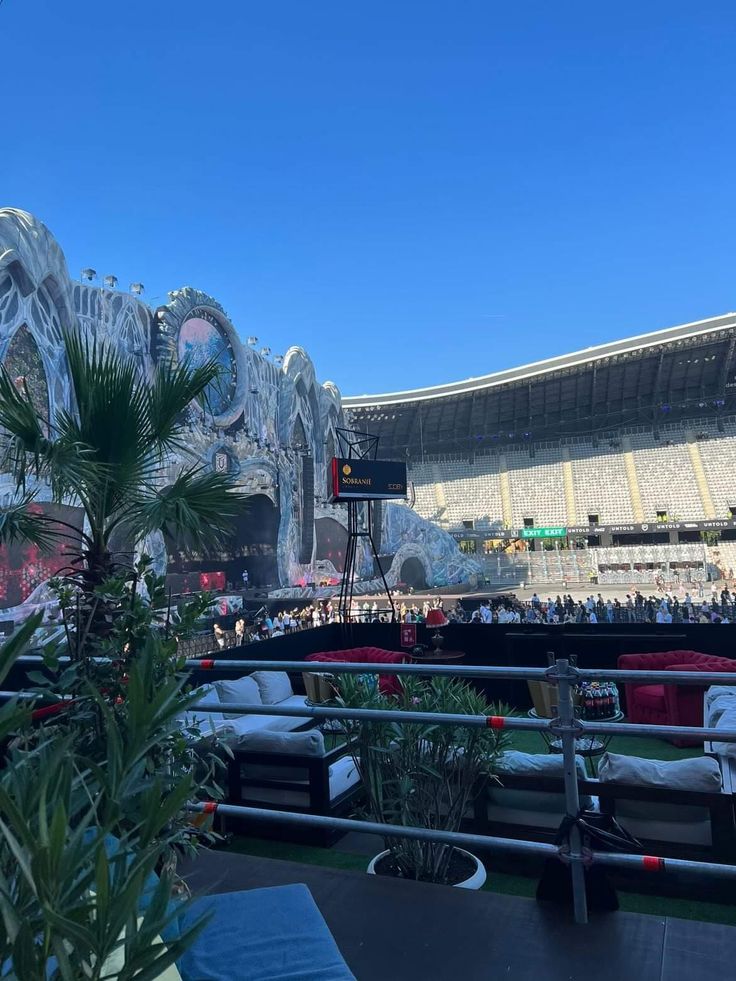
[343,313,736,458]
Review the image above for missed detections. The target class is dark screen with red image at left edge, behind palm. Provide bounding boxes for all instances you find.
[0,504,84,610]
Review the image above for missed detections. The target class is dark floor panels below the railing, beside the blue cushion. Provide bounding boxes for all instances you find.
[182,851,736,981]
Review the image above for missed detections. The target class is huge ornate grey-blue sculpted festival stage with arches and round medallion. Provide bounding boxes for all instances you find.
[0,208,476,609]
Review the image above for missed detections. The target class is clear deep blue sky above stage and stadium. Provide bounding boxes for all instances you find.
[0,0,736,394]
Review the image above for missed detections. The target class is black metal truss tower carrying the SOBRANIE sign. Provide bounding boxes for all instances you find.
[330,428,406,623]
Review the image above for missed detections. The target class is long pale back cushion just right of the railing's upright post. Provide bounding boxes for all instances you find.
[598,753,721,793]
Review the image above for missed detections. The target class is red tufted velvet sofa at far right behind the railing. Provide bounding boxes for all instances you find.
[618,651,736,746]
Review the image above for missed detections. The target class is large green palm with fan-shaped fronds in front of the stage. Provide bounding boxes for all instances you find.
[0,331,249,595]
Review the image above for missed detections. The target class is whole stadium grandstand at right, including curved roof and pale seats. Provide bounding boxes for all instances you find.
[343,313,736,584]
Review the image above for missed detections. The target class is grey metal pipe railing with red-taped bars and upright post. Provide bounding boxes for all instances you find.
[186,658,736,923]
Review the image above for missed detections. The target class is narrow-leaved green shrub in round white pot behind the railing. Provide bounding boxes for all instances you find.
[339,675,508,889]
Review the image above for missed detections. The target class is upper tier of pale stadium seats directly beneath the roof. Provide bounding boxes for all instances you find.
[409,420,736,530]
